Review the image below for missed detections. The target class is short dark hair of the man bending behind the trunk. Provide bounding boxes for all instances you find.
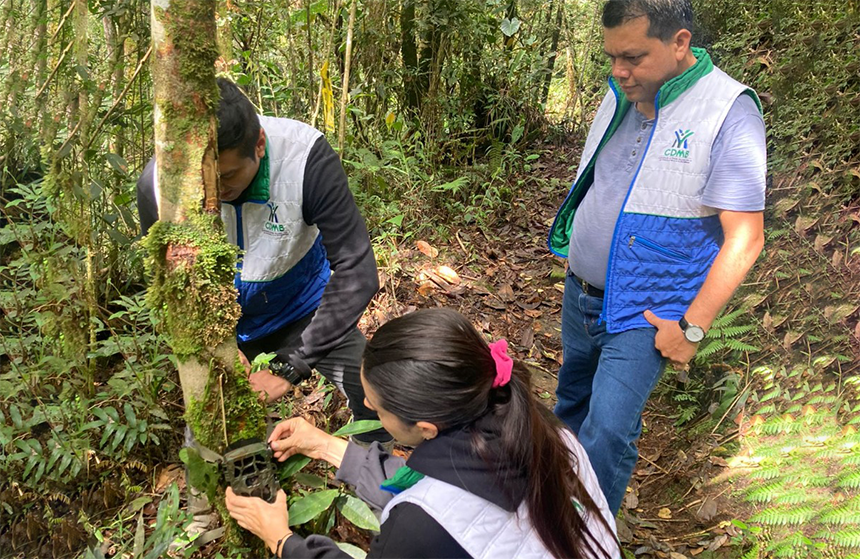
[217,78,260,159]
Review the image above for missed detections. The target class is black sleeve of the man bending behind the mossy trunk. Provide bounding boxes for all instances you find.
[288,137,379,372]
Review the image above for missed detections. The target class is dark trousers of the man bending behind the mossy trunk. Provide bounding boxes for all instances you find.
[239,313,391,443]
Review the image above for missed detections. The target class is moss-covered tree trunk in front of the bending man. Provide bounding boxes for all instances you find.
[144,0,265,552]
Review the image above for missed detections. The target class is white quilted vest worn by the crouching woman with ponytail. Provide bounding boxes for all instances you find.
[381,430,619,559]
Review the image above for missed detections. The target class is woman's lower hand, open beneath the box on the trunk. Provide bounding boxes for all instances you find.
[225,487,293,555]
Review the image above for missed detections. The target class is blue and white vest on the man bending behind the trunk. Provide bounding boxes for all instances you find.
[221,116,331,341]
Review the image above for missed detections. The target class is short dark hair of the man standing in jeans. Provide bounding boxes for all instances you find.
[603,0,693,42]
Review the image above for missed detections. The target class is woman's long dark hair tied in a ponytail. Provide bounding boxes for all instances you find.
[363,309,611,559]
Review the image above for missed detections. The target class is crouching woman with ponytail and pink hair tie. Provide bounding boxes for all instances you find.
[227,309,621,559]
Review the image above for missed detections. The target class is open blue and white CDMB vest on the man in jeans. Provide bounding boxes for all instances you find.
[548,49,761,333]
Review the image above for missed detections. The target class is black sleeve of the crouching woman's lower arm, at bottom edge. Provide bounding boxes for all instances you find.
[281,503,472,559]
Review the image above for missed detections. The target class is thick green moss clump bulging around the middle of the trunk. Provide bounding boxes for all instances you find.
[143,212,241,360]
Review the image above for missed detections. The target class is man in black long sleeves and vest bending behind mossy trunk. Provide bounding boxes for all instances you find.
[137,78,391,444]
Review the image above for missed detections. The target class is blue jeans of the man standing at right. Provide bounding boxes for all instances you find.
[555,273,666,514]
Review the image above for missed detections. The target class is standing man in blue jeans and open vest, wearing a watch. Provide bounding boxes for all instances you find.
[549,0,767,513]
